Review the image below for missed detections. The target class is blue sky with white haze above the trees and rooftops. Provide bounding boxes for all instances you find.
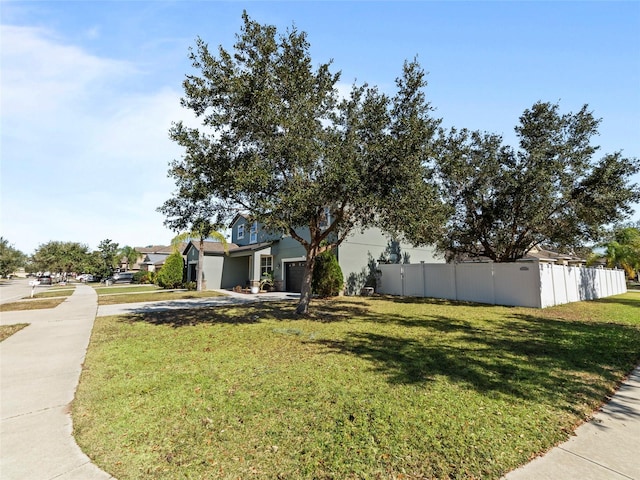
[0,0,640,254]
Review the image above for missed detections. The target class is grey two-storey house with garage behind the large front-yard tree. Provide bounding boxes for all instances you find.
[183,214,444,294]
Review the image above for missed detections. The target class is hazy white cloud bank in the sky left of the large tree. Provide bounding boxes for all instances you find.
[0,26,194,253]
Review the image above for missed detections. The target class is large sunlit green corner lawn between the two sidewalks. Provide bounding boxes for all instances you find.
[73,293,640,480]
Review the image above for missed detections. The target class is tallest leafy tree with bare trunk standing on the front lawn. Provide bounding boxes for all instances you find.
[169,12,439,314]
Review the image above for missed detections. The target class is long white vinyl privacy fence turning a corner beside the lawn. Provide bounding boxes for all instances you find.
[377,262,627,308]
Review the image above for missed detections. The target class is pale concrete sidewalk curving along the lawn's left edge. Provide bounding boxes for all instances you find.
[0,285,113,480]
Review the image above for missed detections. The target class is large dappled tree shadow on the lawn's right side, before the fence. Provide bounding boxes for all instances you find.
[308,302,640,413]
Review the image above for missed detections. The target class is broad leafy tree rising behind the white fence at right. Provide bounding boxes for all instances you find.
[428,102,640,262]
